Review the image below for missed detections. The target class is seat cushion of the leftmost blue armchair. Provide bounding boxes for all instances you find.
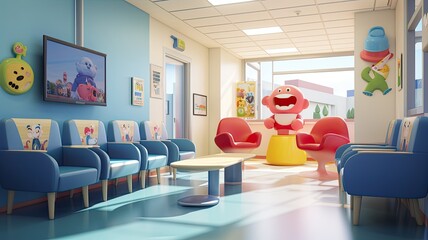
[58,166,98,192]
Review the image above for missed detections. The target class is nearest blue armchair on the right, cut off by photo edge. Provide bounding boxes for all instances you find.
[342,117,428,225]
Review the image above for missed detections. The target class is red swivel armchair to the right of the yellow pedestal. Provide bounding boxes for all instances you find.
[296,117,349,180]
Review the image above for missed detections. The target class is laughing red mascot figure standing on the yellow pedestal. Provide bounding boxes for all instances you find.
[262,85,309,135]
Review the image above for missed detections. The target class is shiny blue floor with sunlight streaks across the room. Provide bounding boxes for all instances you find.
[0,160,428,240]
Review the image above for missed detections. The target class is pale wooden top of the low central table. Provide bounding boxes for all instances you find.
[171,153,256,171]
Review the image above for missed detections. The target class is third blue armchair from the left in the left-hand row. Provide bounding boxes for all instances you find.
[108,120,169,188]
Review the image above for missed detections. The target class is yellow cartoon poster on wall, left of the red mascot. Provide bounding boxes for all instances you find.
[236,82,256,118]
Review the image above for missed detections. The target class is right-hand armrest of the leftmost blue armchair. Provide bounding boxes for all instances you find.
[62,146,101,178]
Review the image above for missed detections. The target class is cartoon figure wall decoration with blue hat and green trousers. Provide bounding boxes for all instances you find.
[360,26,394,96]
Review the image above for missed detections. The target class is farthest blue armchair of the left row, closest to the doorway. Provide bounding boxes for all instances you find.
[141,121,196,179]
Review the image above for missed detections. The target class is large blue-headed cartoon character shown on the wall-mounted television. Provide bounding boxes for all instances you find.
[71,57,97,101]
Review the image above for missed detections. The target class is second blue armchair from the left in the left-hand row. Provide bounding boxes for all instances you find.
[63,120,141,201]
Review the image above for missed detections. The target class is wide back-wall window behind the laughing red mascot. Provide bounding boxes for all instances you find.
[245,55,354,119]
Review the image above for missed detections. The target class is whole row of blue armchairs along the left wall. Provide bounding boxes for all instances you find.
[0,118,195,219]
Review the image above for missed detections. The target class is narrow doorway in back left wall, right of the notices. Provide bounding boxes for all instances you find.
[165,55,189,138]
